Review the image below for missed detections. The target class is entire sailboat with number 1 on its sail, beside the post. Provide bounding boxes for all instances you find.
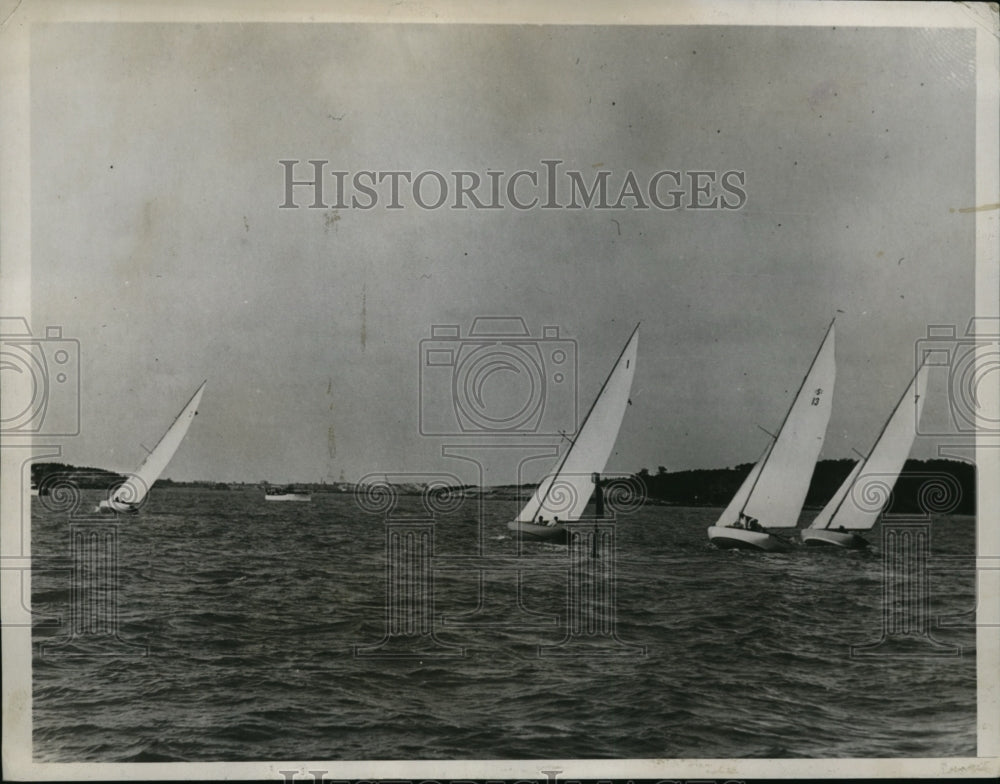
[507,324,639,542]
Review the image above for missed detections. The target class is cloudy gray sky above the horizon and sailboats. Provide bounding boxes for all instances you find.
[31,24,975,481]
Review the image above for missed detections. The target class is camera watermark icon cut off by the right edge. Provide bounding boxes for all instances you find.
[915,317,1000,440]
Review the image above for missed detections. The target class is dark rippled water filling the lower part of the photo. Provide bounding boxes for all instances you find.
[32,488,976,762]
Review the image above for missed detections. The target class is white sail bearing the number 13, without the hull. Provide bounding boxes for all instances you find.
[742,323,836,528]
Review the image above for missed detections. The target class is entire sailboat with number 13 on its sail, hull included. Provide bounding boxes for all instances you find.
[708,321,836,551]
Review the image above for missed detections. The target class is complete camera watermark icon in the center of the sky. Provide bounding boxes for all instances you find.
[420,316,578,436]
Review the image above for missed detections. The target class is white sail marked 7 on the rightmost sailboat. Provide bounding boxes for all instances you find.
[826,365,927,531]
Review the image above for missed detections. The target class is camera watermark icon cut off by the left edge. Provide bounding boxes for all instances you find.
[0,317,80,437]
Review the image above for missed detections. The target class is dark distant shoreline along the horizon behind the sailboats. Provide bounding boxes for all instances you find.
[31,459,976,514]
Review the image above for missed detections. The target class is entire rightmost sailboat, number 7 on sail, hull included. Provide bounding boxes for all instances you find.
[802,365,927,550]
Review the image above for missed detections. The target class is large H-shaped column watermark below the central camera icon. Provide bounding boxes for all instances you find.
[354,474,646,659]
